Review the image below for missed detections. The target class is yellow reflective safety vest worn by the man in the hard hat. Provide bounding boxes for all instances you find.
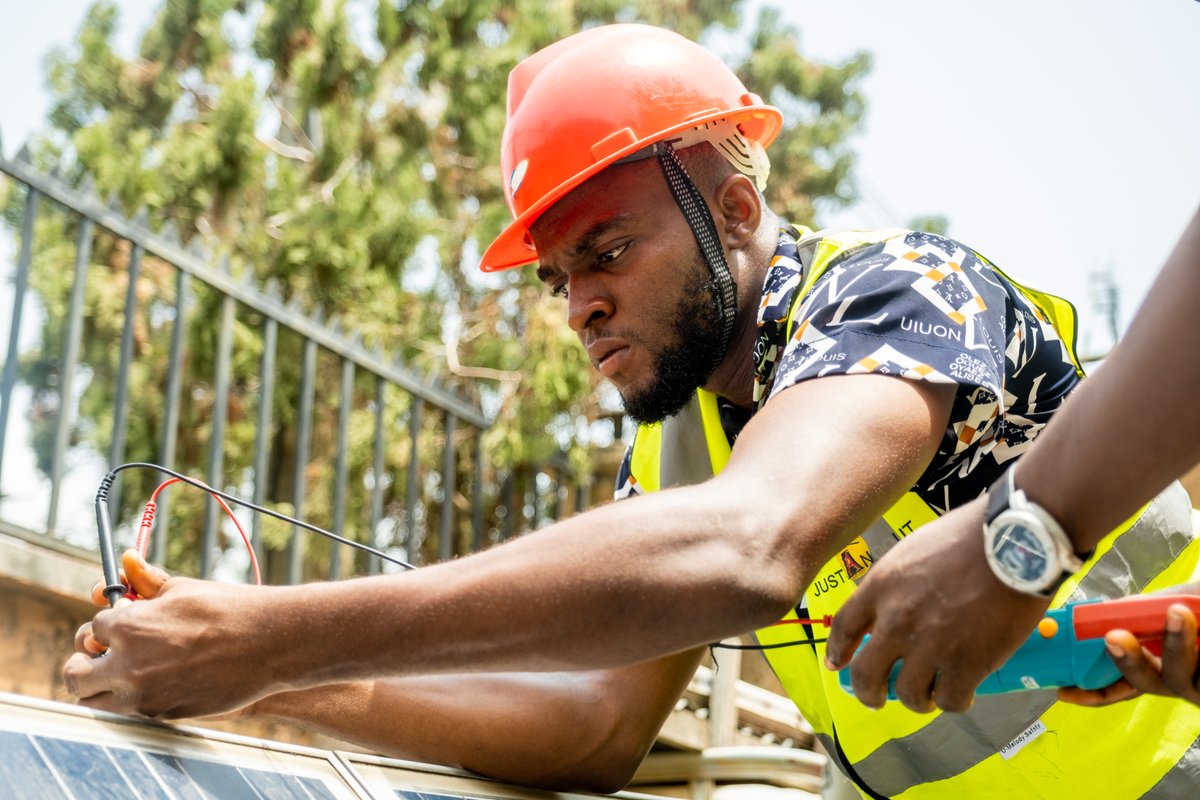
[630,230,1200,800]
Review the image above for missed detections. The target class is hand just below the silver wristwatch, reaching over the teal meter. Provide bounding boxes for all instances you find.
[826,499,1049,712]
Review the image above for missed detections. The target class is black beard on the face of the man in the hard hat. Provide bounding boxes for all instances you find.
[620,259,724,425]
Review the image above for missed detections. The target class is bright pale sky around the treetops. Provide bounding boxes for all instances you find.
[0,0,1200,351]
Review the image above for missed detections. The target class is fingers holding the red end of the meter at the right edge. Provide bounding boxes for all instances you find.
[1058,583,1200,706]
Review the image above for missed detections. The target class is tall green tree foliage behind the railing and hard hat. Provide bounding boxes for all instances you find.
[6,0,869,575]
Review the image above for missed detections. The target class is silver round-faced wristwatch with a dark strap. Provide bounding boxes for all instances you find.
[983,469,1087,597]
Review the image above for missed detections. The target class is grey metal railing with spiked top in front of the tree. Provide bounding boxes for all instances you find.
[0,137,589,583]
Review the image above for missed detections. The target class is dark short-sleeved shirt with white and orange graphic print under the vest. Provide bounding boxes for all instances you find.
[616,228,1079,513]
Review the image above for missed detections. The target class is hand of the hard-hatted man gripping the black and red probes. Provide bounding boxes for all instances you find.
[62,551,270,718]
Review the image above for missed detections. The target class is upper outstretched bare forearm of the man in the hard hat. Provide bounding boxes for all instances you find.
[267,474,803,685]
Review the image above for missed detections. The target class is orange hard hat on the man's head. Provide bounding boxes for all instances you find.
[480,24,782,272]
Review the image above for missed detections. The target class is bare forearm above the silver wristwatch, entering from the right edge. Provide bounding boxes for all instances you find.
[1016,212,1200,552]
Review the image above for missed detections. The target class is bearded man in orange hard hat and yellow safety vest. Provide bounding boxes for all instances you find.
[65,25,1195,798]
